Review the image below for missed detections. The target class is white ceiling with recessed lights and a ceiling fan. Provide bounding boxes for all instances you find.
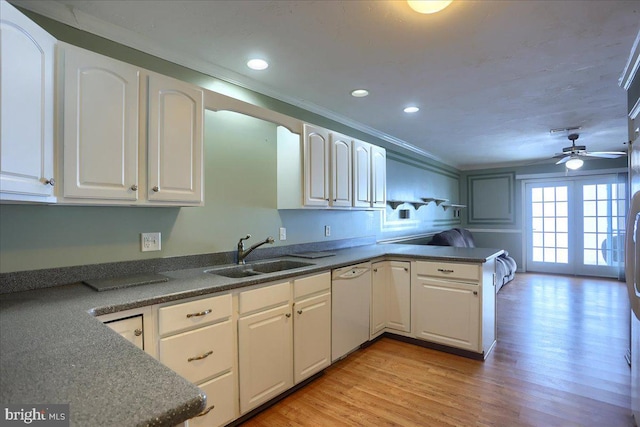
[12,0,640,169]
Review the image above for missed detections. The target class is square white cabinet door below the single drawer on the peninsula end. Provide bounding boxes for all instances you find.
[411,276,482,352]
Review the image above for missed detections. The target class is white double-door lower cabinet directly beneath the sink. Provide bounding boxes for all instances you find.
[238,272,331,414]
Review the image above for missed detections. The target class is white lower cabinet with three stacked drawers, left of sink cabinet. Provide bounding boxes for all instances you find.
[157,294,238,427]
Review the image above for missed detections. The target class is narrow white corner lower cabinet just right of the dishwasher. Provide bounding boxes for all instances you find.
[371,261,411,338]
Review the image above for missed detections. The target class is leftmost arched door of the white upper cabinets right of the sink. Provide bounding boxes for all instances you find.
[303,125,329,206]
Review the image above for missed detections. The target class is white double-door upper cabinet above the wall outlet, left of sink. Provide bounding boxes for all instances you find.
[60,44,204,206]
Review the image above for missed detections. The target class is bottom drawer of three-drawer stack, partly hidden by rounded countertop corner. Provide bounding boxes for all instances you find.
[188,371,236,427]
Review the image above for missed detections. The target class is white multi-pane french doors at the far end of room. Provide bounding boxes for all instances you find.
[525,175,626,277]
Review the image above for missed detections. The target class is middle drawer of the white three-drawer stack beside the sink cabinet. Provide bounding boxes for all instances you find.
[159,320,233,383]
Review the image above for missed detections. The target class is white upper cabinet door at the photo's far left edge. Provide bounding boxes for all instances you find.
[0,1,56,202]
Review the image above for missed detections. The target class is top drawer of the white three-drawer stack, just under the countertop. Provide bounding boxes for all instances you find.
[158,294,231,336]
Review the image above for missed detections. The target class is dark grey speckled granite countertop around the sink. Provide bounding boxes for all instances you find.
[0,244,502,426]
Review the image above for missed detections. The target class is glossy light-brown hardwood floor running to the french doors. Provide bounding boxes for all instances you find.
[243,274,634,427]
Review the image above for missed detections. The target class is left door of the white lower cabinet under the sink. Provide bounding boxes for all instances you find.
[238,304,293,414]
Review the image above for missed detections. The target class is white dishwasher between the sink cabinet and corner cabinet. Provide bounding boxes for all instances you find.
[331,262,371,362]
